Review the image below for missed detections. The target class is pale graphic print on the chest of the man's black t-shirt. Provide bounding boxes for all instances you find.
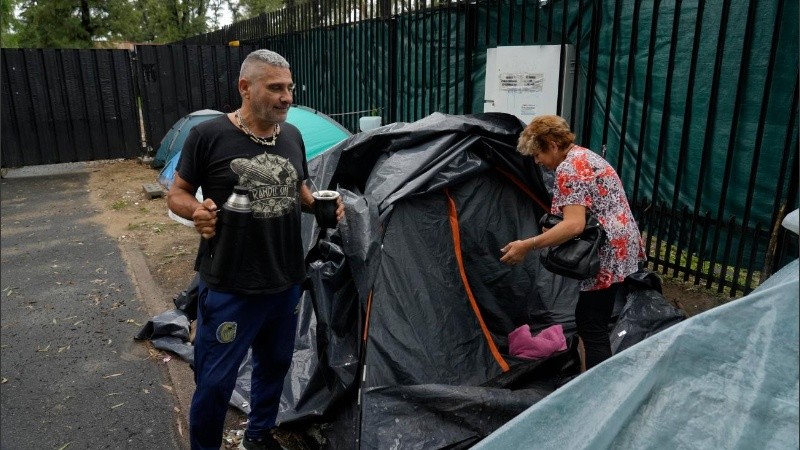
[231,154,297,219]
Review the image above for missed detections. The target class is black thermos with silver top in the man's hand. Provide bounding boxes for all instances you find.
[210,186,252,284]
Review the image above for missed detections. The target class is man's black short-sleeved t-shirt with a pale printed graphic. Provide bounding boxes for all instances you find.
[177,115,308,294]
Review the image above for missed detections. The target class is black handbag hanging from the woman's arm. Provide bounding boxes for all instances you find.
[539,210,606,280]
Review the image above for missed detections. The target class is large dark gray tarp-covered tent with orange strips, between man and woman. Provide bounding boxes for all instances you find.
[278,113,680,449]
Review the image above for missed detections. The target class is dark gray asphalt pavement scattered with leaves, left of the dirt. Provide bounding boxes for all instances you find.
[0,164,186,450]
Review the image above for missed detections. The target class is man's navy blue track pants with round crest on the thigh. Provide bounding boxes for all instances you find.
[189,281,300,450]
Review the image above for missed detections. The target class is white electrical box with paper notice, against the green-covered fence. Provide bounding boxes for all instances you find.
[483,44,575,125]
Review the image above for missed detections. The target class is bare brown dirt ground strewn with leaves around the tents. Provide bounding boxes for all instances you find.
[84,160,730,448]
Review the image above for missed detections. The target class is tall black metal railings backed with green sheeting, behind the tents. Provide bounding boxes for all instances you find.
[178,0,798,297]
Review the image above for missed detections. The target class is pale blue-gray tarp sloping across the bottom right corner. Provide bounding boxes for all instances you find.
[474,260,800,450]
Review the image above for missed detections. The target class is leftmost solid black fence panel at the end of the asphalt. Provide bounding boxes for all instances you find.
[0,48,142,167]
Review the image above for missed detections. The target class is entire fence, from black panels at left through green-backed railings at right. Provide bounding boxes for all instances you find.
[2,0,798,296]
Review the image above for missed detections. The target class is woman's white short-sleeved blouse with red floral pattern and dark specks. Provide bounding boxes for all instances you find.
[550,145,646,291]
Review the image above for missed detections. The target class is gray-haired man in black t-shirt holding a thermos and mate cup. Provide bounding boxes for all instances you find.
[167,50,344,450]
